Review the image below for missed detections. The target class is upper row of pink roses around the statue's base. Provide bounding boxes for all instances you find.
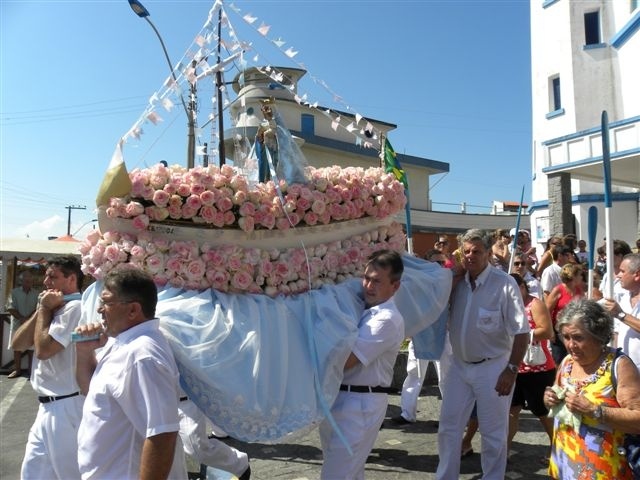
[106,164,406,232]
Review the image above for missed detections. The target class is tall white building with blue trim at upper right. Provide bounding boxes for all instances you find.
[529,0,640,246]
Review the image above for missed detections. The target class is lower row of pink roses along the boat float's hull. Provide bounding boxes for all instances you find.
[80,222,405,296]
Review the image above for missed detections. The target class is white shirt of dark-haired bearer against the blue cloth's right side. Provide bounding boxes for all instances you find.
[342,298,404,387]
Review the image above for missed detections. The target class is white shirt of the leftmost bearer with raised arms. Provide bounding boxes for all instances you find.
[31,300,81,397]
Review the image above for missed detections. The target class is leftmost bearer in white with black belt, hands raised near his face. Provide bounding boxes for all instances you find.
[11,255,84,480]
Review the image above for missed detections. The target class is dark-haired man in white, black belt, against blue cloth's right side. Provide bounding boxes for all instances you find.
[320,250,404,480]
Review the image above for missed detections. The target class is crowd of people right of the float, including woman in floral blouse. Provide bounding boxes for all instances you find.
[392,229,640,479]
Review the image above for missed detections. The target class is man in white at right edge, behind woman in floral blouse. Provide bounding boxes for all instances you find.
[603,253,640,367]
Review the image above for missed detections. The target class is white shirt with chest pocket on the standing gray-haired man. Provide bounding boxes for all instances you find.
[449,265,529,362]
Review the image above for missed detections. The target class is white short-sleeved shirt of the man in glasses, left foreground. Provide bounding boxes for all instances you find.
[78,319,179,480]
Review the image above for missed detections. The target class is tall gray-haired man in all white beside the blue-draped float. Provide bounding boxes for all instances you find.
[436,229,529,480]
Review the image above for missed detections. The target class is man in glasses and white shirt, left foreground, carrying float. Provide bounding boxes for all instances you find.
[76,268,187,480]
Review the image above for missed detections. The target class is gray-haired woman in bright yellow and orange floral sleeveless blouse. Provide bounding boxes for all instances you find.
[544,300,640,480]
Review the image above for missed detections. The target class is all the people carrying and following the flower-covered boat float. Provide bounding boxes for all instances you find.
[2,229,640,480]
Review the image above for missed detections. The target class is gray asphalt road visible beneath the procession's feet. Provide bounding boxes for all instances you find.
[0,374,548,480]
